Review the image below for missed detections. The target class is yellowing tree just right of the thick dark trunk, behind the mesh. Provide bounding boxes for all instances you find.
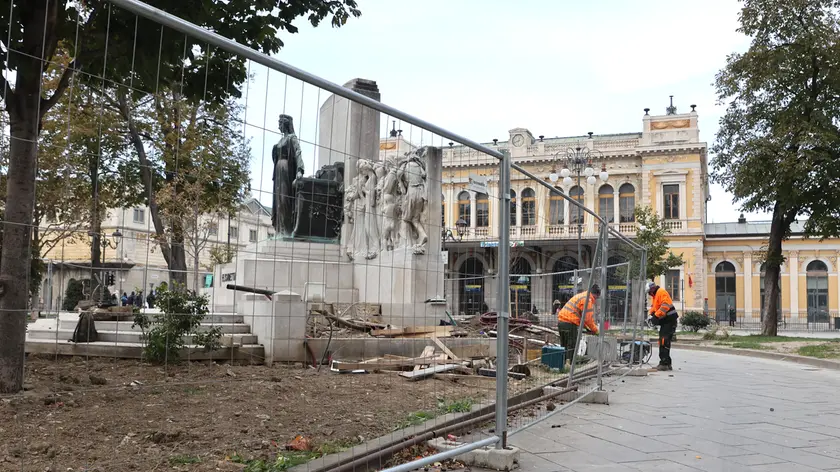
[33,48,145,300]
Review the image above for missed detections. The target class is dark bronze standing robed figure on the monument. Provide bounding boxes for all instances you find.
[271,115,303,236]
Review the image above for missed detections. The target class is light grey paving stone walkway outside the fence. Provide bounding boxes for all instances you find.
[498,350,840,472]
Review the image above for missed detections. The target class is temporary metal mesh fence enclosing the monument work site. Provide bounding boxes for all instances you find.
[0,0,650,471]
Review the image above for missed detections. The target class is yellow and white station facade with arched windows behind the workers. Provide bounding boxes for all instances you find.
[442,102,840,328]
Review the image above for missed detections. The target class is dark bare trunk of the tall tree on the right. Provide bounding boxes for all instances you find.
[761,203,796,336]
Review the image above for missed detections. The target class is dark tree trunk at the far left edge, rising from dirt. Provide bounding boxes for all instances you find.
[0,108,40,393]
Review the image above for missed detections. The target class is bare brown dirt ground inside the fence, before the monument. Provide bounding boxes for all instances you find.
[0,356,487,472]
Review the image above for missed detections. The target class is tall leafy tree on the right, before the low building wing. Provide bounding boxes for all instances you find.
[711,0,840,336]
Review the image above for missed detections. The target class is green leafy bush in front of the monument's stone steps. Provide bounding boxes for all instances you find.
[133,287,222,364]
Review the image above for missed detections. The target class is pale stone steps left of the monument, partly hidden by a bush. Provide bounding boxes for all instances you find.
[26,310,264,363]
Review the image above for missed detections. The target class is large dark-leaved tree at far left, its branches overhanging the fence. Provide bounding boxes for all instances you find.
[0,0,360,393]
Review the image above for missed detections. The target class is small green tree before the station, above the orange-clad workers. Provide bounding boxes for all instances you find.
[630,206,685,280]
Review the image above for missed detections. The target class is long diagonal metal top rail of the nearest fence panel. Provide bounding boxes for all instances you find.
[102,0,502,159]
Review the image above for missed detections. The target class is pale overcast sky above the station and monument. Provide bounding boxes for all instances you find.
[241,0,768,222]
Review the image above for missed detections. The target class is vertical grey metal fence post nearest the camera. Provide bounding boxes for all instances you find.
[495,151,510,449]
